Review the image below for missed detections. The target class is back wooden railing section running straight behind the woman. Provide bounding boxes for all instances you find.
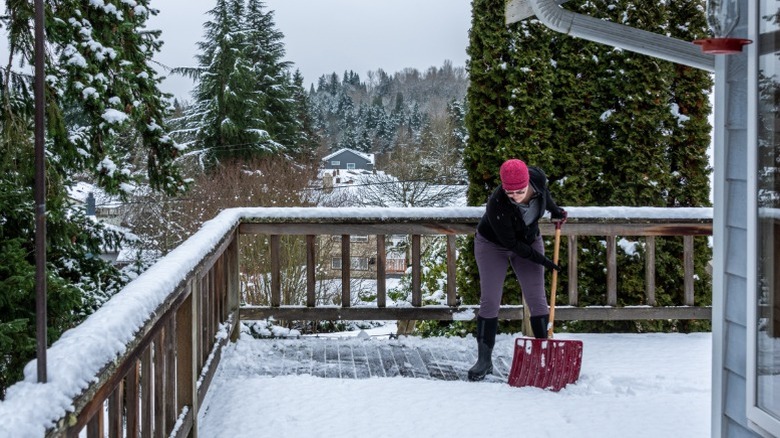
[239,207,712,320]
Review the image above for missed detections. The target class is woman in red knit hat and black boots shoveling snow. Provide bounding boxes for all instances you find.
[469,159,567,381]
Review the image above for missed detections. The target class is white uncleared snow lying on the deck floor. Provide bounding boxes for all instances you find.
[199,329,712,438]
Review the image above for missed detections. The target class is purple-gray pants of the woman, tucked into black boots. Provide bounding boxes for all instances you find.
[474,233,549,318]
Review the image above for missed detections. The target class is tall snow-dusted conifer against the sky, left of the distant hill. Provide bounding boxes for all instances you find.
[174,0,311,164]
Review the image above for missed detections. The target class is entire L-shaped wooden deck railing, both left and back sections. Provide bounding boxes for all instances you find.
[25,207,712,437]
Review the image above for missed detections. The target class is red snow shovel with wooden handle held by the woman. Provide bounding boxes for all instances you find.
[509,221,582,391]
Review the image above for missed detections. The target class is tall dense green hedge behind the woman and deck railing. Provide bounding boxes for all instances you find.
[459,0,712,331]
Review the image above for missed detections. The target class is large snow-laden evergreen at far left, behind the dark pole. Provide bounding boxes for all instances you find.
[0,0,184,397]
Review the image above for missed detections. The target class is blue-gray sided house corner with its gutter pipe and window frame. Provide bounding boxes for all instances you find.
[506,0,780,437]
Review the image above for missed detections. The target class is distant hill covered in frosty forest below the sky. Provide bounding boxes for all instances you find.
[309,61,469,165]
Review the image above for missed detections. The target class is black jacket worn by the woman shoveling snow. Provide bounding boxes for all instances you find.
[477,166,563,264]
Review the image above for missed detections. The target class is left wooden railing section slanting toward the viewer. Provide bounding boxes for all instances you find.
[40,222,239,437]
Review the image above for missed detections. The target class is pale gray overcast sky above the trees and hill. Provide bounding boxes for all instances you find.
[149,0,471,99]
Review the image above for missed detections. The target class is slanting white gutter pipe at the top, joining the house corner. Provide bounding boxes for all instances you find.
[505,0,715,72]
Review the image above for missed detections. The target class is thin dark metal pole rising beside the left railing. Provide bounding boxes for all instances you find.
[34,0,47,383]
